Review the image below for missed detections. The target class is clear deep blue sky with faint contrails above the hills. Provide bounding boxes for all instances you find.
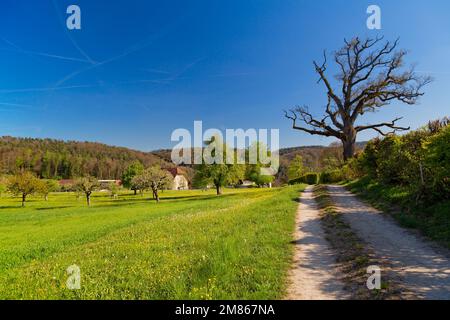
[0,0,450,151]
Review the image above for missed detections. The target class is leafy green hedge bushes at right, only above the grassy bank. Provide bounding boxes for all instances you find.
[354,121,450,204]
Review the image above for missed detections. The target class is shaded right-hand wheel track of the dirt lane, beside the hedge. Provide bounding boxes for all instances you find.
[328,186,450,299]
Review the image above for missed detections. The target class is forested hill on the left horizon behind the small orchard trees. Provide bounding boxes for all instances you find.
[0,137,169,179]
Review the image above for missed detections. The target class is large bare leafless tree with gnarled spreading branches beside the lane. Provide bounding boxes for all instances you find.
[285,37,431,160]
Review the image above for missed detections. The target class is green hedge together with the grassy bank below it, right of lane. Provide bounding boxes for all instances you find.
[349,119,450,246]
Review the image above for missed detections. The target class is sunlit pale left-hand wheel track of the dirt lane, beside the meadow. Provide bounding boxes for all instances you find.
[287,187,348,300]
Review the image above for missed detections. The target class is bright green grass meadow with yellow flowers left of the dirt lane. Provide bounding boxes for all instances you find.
[0,186,302,299]
